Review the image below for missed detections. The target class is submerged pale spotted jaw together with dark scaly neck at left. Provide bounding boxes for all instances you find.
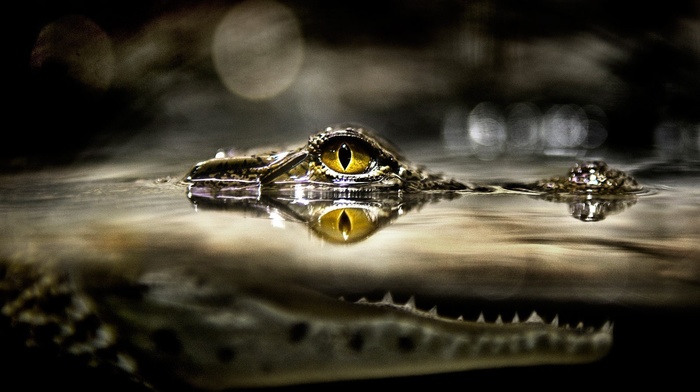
[2,268,612,390]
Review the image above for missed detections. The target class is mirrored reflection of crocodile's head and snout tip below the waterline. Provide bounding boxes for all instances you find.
[187,180,638,244]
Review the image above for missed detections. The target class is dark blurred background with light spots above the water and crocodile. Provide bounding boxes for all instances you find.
[9,0,700,171]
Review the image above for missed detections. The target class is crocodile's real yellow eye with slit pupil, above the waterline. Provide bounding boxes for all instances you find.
[321,138,373,174]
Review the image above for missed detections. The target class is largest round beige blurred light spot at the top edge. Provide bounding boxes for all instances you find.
[212,0,304,100]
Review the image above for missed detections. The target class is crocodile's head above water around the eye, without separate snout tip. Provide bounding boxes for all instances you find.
[183,125,467,193]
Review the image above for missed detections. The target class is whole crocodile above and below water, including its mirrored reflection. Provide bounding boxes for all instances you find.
[0,125,642,390]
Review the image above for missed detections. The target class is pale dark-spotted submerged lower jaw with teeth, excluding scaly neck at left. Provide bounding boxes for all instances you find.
[104,276,612,389]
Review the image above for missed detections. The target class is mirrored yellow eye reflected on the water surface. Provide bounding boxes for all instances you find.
[315,207,376,243]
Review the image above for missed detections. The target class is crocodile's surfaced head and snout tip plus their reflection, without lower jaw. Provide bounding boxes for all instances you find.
[182,124,644,243]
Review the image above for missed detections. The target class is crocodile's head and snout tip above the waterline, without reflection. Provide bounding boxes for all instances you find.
[183,124,642,197]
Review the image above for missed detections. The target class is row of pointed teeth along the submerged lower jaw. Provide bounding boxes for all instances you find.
[340,292,613,332]
